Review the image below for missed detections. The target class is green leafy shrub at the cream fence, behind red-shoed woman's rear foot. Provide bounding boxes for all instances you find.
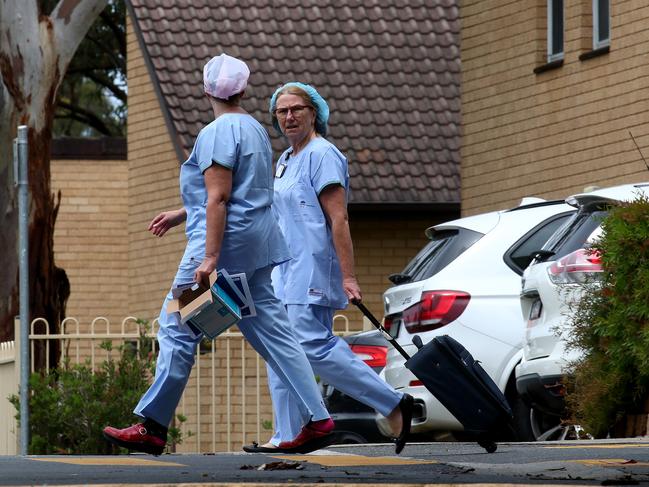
[9,330,185,454]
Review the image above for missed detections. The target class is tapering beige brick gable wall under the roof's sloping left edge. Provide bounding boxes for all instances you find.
[127,15,185,319]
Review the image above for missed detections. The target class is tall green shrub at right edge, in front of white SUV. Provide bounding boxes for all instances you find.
[566,197,649,437]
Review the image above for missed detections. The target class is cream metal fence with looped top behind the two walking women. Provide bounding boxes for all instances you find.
[0,315,359,455]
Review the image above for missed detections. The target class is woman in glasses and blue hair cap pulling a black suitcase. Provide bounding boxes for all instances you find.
[251,82,413,453]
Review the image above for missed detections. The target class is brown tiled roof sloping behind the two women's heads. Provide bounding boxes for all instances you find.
[130,0,460,203]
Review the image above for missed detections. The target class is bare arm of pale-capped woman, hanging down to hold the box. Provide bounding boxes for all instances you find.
[194,164,232,286]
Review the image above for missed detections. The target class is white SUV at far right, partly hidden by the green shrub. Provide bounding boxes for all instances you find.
[516,183,649,440]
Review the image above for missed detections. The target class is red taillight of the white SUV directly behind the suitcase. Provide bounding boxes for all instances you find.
[401,291,471,333]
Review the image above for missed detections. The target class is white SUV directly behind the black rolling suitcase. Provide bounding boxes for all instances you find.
[377,199,574,440]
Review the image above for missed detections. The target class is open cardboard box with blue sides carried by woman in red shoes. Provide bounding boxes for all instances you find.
[167,271,241,339]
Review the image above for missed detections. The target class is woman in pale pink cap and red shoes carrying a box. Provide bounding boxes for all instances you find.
[104,54,334,455]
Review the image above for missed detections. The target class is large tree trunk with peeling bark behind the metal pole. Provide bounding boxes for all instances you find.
[0,0,108,366]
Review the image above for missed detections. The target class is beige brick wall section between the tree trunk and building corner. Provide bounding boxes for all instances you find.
[51,160,128,331]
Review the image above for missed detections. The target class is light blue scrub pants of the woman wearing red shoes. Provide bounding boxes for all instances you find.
[134,263,329,428]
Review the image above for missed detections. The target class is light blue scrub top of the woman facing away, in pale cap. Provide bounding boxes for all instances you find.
[180,113,290,274]
